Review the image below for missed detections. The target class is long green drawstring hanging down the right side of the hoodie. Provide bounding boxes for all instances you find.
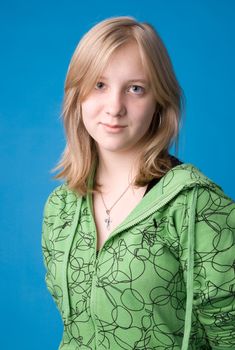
[181,186,198,350]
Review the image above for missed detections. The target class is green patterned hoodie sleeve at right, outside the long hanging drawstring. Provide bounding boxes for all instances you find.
[184,187,235,349]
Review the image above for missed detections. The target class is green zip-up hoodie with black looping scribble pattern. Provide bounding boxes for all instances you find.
[42,164,235,350]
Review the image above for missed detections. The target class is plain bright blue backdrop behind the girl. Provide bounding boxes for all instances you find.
[0,0,235,350]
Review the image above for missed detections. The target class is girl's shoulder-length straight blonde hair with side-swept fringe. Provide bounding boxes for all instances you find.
[54,17,183,195]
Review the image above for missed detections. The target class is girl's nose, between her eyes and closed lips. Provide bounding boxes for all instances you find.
[106,90,126,117]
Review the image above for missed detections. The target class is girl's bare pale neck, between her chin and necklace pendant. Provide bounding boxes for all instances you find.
[96,151,138,188]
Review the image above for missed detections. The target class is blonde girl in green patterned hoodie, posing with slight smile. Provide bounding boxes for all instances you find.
[42,17,235,350]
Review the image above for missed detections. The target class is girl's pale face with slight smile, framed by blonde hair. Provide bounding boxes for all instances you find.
[82,43,156,156]
